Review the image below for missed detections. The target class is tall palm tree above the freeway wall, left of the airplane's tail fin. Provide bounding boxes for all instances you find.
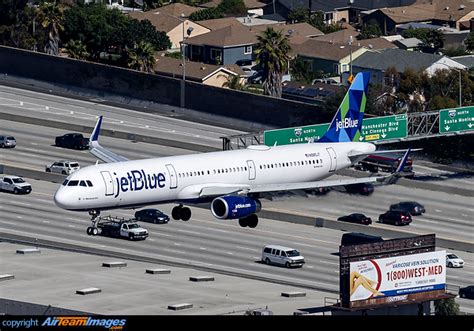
[255,27,291,98]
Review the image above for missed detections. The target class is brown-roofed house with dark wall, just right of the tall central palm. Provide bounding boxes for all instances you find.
[291,39,368,76]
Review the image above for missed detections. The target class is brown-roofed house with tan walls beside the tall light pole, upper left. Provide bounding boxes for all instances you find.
[129,7,210,49]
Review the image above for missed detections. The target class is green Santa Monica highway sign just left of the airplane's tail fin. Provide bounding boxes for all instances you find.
[263,123,329,146]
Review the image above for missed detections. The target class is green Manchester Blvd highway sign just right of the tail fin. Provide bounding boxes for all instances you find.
[361,114,408,142]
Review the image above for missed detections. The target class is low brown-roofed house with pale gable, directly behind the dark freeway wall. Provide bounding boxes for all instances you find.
[154,53,245,87]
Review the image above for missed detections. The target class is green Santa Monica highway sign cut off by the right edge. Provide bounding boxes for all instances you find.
[439,107,474,133]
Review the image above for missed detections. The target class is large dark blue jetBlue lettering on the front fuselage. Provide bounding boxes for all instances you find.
[114,169,166,198]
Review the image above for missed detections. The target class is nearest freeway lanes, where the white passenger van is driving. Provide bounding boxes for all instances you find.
[0,180,474,313]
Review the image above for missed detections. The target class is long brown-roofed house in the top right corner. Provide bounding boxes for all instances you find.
[361,0,474,35]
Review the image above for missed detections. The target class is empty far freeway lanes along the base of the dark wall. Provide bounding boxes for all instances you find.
[0,85,244,148]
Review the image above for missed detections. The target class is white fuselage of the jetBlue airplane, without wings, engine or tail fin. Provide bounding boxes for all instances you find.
[54,142,375,210]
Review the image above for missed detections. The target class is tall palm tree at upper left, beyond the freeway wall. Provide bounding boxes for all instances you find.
[38,2,64,55]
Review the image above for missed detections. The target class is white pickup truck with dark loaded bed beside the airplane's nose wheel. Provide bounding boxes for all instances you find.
[94,218,148,240]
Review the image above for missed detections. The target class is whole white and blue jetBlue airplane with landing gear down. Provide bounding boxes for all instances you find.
[54,72,410,235]
